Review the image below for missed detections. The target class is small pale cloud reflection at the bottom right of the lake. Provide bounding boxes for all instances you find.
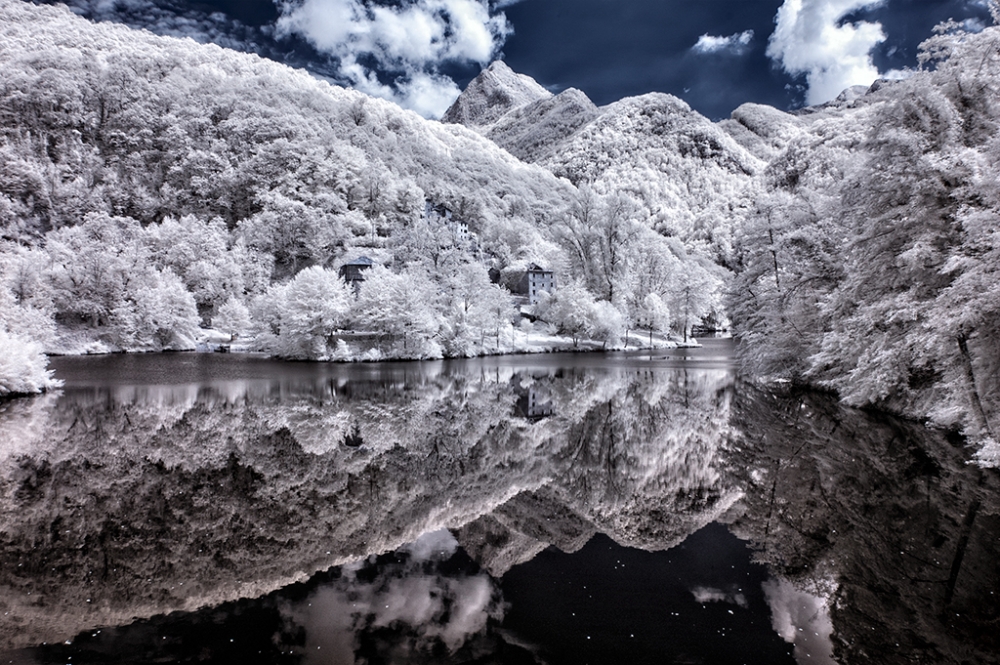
[763,579,836,665]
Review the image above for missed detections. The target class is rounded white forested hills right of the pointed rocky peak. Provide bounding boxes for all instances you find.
[444,65,760,263]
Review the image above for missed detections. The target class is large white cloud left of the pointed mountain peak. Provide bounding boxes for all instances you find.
[277,0,511,117]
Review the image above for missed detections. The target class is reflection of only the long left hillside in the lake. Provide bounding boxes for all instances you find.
[0,377,522,642]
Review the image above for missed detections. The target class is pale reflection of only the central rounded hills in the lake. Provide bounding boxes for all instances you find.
[459,369,738,573]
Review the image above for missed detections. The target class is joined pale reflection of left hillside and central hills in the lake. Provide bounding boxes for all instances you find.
[0,358,738,646]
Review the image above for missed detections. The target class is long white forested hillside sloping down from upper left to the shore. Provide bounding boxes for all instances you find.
[0,0,722,392]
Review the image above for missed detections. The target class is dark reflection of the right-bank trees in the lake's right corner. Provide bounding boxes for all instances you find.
[733,388,1000,664]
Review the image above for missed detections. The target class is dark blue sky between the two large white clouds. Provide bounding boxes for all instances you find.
[503,0,795,118]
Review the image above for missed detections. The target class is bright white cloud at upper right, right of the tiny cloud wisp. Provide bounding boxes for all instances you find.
[767,0,885,104]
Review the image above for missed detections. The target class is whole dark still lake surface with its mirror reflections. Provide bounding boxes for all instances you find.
[0,340,1000,665]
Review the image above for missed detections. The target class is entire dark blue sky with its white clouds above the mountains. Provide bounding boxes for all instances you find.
[47,0,989,119]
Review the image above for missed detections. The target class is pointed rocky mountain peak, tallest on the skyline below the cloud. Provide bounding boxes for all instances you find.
[441,60,552,127]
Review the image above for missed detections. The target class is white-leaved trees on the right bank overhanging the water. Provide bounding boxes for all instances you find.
[728,19,1000,455]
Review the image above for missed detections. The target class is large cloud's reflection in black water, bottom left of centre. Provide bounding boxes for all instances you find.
[291,530,501,664]
